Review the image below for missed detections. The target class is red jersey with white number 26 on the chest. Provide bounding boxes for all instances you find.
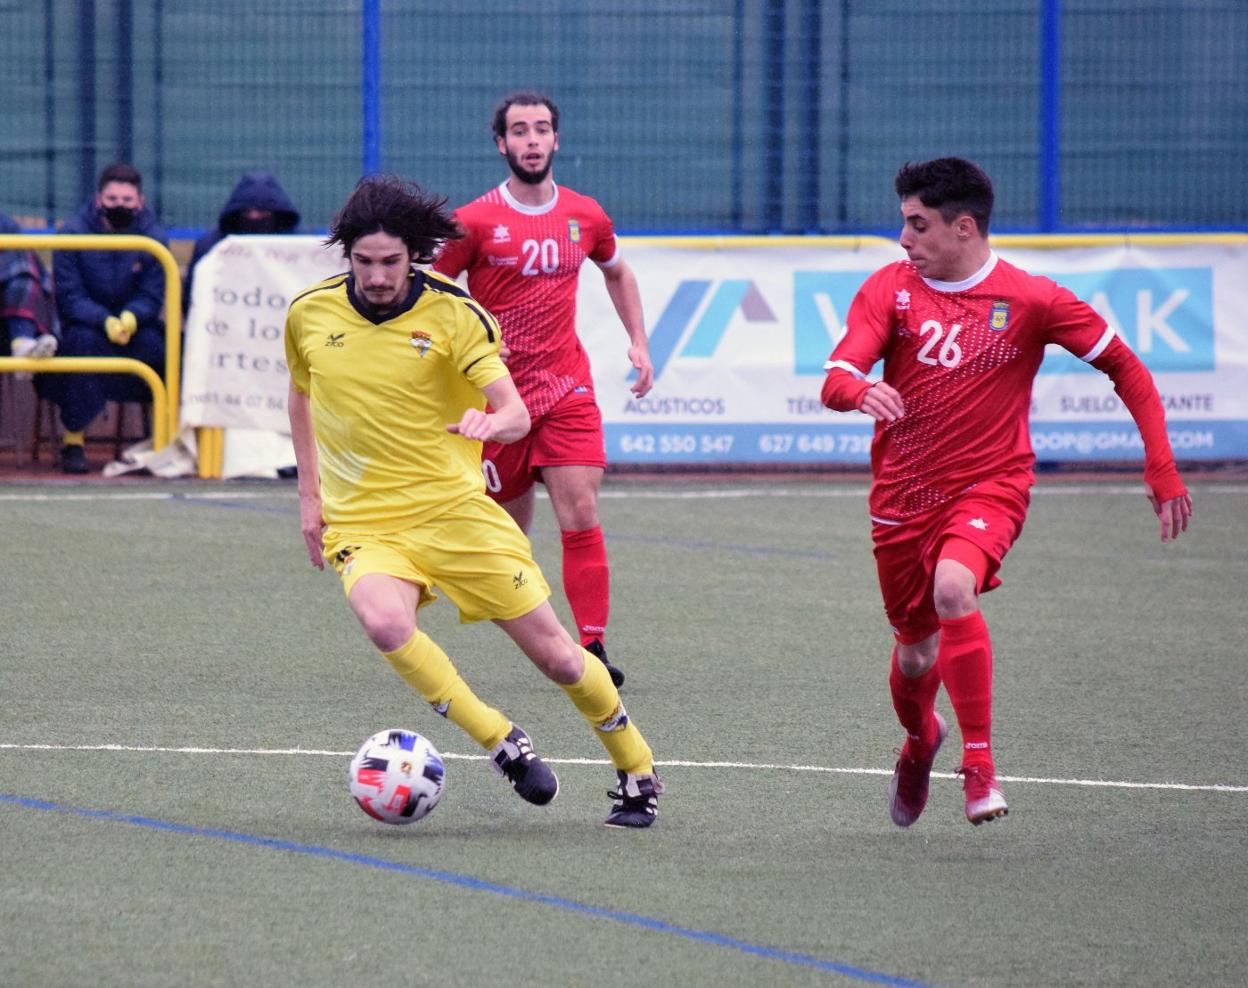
[822,253,1113,523]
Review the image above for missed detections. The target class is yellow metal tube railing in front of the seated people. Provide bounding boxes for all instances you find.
[0,233,182,449]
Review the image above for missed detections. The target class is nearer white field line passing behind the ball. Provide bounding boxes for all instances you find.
[0,742,1248,792]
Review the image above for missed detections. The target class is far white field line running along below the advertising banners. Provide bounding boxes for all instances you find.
[0,480,1248,503]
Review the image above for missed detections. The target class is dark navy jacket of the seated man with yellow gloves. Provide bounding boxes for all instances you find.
[52,198,168,333]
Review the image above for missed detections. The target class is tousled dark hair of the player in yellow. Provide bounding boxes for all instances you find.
[326,175,463,264]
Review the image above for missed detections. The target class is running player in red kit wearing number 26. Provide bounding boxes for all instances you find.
[821,158,1192,827]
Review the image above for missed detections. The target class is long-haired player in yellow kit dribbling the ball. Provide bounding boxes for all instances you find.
[286,176,663,827]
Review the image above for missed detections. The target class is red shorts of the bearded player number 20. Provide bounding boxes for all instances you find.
[480,387,607,504]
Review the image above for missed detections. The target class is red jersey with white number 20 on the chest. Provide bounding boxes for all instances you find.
[433,182,619,418]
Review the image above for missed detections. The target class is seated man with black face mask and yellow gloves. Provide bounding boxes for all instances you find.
[39,162,168,474]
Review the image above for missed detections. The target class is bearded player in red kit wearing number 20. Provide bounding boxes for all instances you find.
[434,92,654,686]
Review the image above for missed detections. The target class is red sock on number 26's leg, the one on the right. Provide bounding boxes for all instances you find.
[936,611,992,768]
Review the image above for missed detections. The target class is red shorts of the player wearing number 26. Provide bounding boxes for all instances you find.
[871,482,1031,645]
